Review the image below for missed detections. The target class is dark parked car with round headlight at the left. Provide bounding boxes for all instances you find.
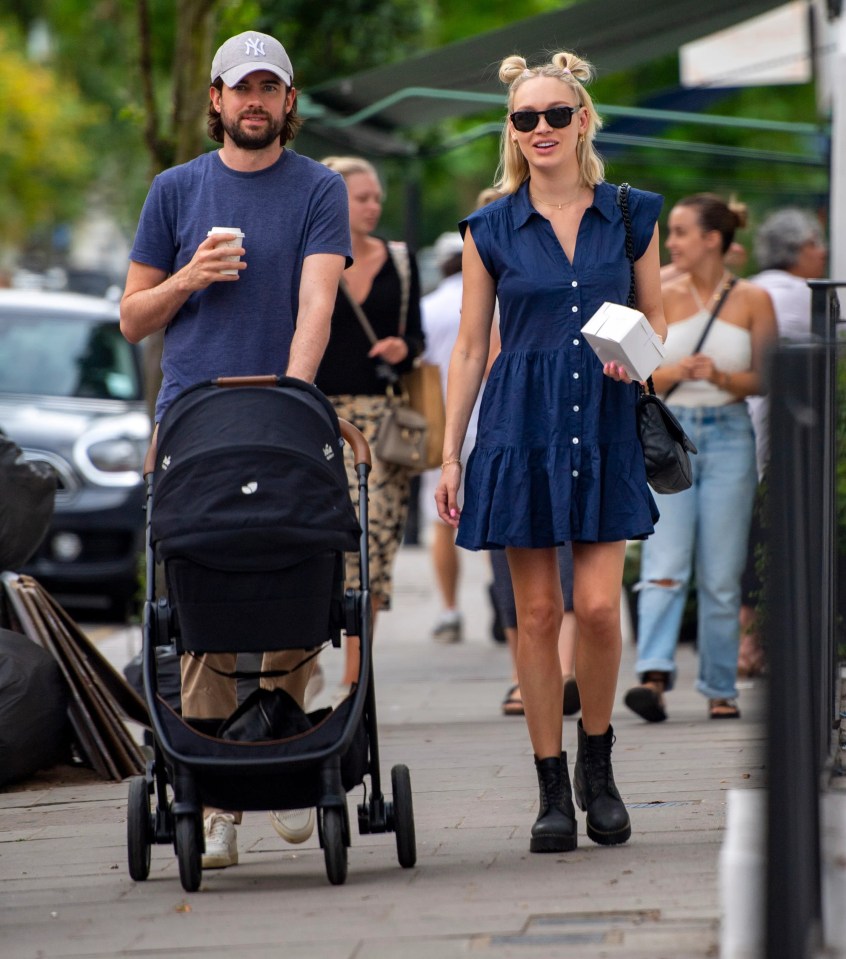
[0,290,151,615]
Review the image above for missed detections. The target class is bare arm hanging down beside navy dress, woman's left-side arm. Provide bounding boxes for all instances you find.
[435,227,496,527]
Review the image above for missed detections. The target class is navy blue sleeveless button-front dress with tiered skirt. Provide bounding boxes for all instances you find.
[456,182,663,549]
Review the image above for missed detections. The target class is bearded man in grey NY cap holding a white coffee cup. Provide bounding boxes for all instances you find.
[121,31,351,869]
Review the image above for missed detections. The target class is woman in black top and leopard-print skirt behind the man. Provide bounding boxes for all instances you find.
[316,157,423,703]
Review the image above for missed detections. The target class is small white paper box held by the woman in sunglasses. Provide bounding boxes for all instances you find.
[582,303,664,380]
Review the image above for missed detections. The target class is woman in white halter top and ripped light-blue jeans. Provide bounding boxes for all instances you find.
[625,193,776,722]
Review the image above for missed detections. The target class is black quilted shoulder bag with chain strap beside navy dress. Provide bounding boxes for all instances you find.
[617,183,700,493]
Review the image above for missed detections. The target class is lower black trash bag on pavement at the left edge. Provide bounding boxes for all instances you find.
[0,629,71,786]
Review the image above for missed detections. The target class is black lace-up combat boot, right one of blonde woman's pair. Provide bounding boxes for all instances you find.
[573,719,632,846]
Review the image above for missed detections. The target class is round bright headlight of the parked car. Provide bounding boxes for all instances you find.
[73,413,150,486]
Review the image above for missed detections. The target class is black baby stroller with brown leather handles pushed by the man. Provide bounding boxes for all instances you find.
[127,376,417,892]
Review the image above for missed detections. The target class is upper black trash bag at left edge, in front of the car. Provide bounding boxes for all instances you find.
[0,430,56,570]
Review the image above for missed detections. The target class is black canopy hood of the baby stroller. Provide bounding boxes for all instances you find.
[151,379,361,570]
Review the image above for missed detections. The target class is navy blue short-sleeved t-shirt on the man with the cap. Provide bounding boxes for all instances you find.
[130,149,351,421]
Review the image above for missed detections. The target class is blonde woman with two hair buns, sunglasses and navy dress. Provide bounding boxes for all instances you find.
[436,52,665,852]
